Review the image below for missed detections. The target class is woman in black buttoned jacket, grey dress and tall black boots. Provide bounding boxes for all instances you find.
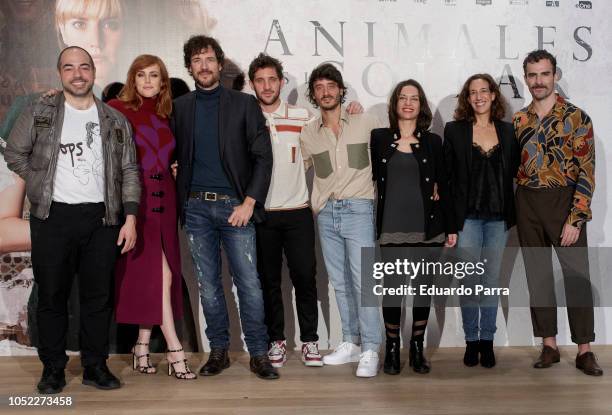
[370,79,457,374]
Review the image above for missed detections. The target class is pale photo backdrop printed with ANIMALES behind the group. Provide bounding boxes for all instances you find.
[0,0,612,355]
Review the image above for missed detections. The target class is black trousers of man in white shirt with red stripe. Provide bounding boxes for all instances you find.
[257,207,319,342]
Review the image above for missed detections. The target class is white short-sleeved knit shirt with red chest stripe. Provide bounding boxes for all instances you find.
[263,101,310,210]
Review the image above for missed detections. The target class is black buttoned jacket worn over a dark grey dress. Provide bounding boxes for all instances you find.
[370,128,456,239]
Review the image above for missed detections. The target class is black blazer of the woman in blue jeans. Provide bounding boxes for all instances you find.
[444,121,520,230]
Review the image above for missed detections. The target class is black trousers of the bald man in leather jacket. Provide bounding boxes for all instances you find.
[30,202,119,368]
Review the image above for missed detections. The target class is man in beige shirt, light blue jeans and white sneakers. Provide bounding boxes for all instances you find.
[301,64,382,377]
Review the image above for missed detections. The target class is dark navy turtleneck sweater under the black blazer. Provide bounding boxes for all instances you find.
[191,85,236,196]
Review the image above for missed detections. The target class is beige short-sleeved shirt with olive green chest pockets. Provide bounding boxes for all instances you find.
[300,108,380,214]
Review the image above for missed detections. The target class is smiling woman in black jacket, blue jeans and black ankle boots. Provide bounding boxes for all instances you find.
[444,74,519,367]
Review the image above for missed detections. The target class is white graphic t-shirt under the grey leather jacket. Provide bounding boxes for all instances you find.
[53,103,104,203]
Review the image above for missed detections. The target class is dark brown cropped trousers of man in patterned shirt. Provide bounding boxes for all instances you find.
[516,186,595,344]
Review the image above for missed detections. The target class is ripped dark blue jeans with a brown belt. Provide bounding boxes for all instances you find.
[185,198,268,356]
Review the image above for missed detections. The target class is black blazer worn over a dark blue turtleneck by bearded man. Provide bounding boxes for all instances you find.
[170,88,272,224]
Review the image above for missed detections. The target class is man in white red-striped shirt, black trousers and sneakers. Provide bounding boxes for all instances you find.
[249,53,323,367]
